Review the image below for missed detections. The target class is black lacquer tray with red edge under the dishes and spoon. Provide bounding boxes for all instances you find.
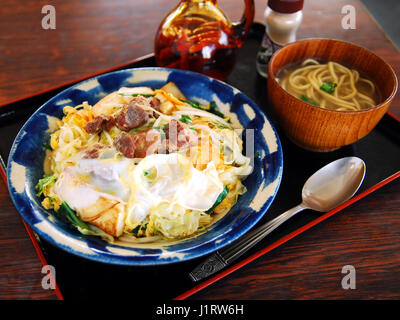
[0,24,400,299]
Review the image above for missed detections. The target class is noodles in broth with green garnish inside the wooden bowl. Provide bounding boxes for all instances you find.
[277,59,377,111]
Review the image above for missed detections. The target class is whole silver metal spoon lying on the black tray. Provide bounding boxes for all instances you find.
[189,157,365,281]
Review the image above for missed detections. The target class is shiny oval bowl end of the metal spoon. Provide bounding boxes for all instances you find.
[302,157,366,212]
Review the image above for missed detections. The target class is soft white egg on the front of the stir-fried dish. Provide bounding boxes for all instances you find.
[54,153,224,236]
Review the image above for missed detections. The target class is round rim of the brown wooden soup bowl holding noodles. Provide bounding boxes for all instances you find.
[268,37,399,115]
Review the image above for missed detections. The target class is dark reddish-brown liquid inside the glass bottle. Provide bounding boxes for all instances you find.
[155,15,242,80]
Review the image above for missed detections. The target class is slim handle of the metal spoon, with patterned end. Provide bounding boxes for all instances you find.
[189,204,306,281]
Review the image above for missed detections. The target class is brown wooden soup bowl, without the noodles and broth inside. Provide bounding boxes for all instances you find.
[268,39,397,151]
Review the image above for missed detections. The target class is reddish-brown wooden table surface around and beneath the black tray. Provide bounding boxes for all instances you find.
[0,0,400,299]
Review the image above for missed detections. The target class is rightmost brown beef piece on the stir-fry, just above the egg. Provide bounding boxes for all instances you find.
[165,119,197,152]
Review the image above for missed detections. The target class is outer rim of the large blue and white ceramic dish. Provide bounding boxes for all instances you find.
[3,67,283,267]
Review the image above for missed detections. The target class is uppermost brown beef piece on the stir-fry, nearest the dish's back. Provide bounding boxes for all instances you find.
[115,96,150,131]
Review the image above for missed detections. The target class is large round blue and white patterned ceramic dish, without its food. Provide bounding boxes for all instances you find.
[7,68,283,265]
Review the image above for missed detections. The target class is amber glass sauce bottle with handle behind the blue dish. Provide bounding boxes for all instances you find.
[154,0,254,80]
